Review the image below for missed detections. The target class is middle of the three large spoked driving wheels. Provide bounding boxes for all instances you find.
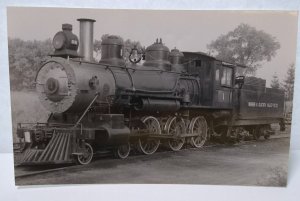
[166,117,185,151]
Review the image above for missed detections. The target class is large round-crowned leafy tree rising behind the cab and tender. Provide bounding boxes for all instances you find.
[207,24,280,75]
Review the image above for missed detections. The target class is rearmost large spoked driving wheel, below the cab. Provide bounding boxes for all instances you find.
[189,116,207,148]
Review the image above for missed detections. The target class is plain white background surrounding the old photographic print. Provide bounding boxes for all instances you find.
[0,0,300,201]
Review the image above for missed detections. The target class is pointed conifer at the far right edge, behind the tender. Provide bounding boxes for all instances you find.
[283,64,295,100]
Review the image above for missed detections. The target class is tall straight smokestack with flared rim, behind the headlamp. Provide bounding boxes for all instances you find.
[77,18,96,61]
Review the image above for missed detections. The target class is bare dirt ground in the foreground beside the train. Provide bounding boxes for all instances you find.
[16,133,290,186]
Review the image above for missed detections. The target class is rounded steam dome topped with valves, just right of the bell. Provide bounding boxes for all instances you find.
[143,39,171,71]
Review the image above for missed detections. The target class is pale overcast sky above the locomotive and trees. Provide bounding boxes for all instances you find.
[7,7,298,85]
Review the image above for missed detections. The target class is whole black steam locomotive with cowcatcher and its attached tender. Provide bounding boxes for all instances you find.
[17,19,284,165]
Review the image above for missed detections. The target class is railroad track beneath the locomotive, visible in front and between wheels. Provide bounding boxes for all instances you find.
[15,134,290,179]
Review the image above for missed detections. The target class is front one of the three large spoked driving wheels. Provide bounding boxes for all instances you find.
[138,116,161,155]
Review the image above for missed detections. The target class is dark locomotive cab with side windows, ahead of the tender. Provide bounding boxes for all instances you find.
[183,52,235,109]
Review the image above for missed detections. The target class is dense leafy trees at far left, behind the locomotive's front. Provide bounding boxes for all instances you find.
[8,38,53,90]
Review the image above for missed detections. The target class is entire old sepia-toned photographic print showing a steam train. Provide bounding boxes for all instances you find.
[7,7,298,187]
